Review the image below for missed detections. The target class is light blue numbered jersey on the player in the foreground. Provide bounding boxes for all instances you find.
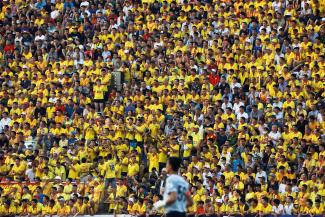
[164,174,189,213]
